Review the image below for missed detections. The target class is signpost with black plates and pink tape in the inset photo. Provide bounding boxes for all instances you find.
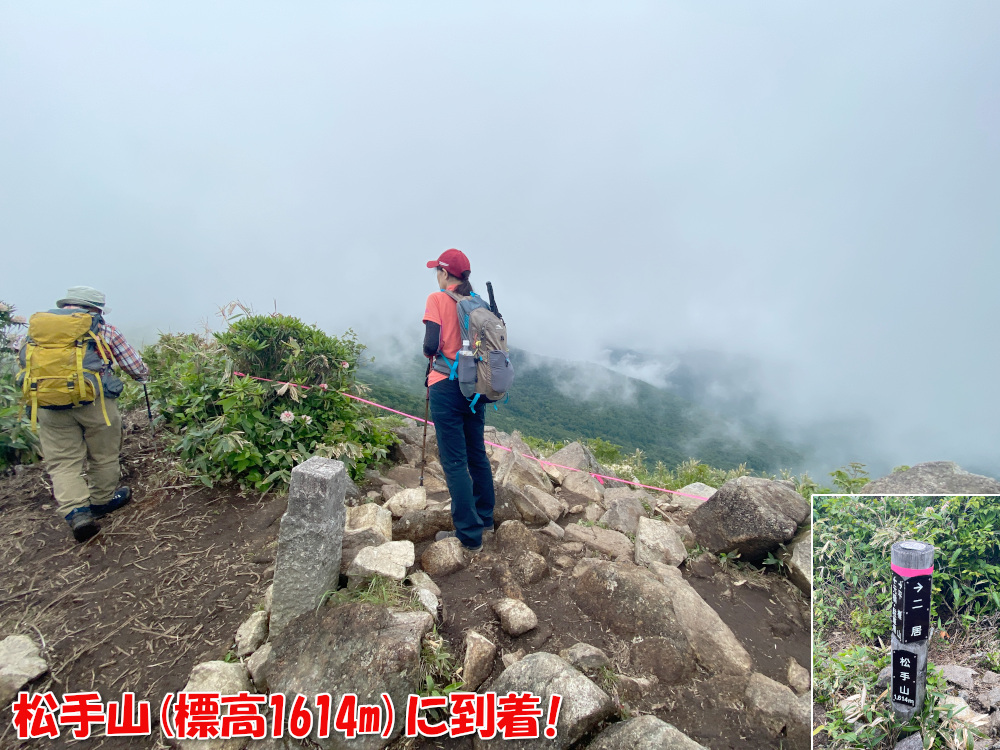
[890,541,934,721]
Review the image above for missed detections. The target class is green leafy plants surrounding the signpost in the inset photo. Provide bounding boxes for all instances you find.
[813,496,1000,748]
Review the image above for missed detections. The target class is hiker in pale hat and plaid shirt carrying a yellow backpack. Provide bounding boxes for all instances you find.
[17,286,149,542]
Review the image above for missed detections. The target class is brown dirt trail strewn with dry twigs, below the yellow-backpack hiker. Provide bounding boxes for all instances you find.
[0,415,285,750]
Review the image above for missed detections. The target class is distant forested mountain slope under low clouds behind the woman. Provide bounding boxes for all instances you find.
[359,350,802,472]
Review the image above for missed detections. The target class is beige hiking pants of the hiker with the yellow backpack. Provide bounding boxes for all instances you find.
[38,398,122,517]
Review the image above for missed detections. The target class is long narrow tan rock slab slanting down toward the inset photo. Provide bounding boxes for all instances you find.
[650,563,753,679]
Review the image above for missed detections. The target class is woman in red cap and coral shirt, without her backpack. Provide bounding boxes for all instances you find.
[424,249,496,552]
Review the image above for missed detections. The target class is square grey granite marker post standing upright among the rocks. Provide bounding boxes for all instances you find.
[270,456,347,635]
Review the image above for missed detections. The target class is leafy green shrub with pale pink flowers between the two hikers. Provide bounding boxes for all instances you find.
[143,315,393,490]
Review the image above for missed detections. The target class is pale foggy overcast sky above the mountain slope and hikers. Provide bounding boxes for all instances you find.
[0,0,1000,476]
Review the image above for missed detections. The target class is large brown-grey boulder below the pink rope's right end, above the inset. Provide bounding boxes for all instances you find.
[688,477,810,562]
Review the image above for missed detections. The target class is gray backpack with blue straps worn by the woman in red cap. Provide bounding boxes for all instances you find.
[434,291,514,412]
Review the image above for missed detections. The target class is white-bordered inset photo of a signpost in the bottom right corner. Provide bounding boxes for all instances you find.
[813,495,1000,750]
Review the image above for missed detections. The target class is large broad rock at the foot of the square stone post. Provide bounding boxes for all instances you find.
[268,602,434,750]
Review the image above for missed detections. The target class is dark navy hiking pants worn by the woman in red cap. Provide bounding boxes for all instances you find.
[430,380,496,547]
